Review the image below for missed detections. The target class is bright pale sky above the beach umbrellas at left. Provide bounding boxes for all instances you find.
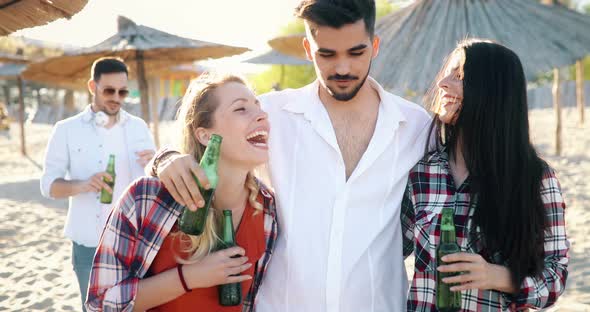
[15,0,299,50]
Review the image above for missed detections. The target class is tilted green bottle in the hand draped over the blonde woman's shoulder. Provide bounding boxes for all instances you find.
[178,134,222,235]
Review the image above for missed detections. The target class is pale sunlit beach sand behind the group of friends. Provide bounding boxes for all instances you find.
[0,108,590,311]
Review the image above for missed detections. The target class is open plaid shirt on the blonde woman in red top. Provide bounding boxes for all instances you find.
[86,177,278,311]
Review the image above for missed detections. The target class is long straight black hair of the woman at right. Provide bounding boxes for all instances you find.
[426,39,547,288]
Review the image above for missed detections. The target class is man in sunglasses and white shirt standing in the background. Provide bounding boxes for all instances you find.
[40,58,155,307]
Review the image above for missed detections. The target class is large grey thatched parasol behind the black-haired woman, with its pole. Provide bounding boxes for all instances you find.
[372,0,590,154]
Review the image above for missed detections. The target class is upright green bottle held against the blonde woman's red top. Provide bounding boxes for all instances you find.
[217,210,242,306]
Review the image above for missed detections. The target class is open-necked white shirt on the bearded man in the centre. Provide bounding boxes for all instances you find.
[256,78,430,312]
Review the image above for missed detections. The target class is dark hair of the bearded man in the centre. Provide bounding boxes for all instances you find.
[295,0,376,38]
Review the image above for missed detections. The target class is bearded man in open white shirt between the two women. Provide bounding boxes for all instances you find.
[150,0,430,312]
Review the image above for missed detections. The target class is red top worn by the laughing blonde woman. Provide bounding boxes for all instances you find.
[148,202,266,312]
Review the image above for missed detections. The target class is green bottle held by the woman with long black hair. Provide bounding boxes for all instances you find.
[436,208,461,312]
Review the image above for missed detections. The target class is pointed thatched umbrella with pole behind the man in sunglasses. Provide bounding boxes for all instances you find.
[24,16,248,147]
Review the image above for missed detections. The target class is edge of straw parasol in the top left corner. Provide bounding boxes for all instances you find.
[0,0,88,36]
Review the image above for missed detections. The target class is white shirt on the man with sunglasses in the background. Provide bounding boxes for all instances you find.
[40,106,155,247]
